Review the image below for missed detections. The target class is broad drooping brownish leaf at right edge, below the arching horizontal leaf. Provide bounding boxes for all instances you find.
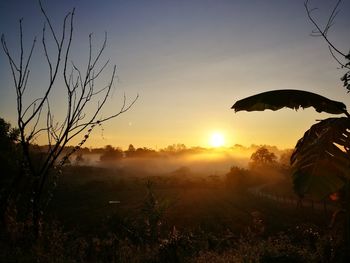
[291,117,350,199]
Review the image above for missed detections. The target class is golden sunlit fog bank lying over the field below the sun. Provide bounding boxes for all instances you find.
[72,145,285,176]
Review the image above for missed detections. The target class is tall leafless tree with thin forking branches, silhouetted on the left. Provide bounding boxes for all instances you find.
[1,0,138,238]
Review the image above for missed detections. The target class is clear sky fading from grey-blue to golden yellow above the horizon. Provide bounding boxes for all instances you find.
[0,0,350,149]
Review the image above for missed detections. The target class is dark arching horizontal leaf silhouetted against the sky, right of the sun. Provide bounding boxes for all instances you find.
[232,90,347,114]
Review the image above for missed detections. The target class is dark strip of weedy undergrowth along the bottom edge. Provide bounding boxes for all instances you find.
[0,217,344,263]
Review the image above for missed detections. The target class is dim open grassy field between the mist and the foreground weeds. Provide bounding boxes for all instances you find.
[49,167,329,236]
